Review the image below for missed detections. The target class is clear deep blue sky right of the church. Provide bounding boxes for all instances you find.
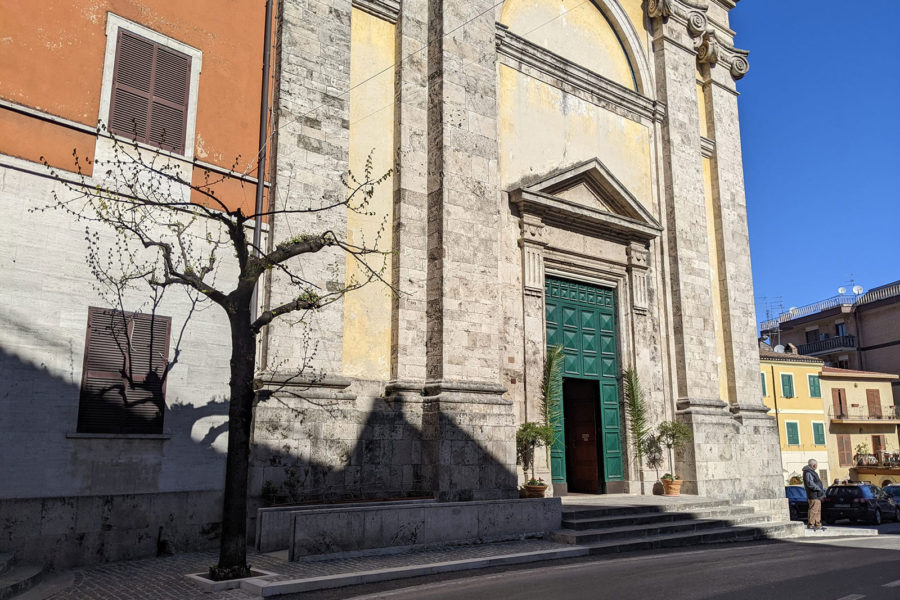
[731,0,900,321]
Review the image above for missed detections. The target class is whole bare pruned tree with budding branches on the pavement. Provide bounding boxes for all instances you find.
[39,124,390,579]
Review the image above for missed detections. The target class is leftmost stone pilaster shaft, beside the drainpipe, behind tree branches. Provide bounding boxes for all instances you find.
[264,0,351,374]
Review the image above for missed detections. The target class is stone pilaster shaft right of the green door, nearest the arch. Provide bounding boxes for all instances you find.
[650,9,719,399]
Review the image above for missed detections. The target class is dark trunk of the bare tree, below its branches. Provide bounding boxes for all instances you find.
[210,299,256,579]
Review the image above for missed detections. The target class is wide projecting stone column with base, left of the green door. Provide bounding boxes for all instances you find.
[423,0,516,500]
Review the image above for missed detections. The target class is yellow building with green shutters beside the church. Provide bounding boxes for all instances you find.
[759,344,830,483]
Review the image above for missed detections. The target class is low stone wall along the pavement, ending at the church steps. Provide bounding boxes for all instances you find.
[280,498,562,560]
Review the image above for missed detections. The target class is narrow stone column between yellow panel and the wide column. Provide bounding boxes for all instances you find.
[388,0,428,397]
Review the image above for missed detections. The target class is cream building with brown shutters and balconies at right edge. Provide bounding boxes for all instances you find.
[821,367,900,485]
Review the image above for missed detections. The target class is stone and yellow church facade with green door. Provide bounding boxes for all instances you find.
[254,0,782,508]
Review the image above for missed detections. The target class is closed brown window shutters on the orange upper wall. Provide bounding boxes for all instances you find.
[109,29,191,153]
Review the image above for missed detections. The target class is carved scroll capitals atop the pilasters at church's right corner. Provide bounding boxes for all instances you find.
[646,0,750,80]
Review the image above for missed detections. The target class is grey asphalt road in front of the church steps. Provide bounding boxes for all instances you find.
[326,523,900,600]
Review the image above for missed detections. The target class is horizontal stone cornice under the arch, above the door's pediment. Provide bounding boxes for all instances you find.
[497,23,665,120]
